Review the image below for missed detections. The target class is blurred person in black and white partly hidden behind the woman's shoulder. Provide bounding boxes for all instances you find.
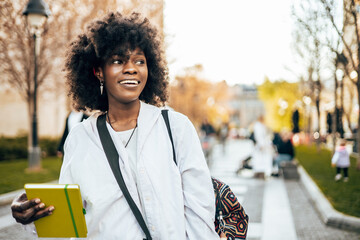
[57,109,89,157]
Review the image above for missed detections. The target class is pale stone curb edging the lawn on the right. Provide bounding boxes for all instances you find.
[298,165,360,232]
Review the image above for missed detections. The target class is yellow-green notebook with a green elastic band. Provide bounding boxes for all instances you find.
[24,184,87,238]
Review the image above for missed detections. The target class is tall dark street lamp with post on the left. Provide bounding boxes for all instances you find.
[23,0,50,169]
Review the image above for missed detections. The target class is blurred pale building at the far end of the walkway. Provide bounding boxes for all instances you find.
[229,84,265,128]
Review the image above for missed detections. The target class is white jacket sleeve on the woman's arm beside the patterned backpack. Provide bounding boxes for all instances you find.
[175,117,219,240]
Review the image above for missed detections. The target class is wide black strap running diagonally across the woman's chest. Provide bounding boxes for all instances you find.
[96,115,152,240]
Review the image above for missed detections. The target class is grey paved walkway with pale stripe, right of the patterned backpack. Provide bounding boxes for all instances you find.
[210,140,360,240]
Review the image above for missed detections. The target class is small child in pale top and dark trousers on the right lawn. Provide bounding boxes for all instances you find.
[331,139,350,182]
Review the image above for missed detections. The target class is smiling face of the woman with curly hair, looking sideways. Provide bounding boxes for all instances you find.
[99,48,148,106]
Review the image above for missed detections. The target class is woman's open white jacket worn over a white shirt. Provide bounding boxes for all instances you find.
[59,103,219,240]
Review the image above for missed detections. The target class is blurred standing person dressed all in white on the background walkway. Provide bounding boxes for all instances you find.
[252,116,273,178]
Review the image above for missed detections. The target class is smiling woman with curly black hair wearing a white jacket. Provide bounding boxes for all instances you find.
[12,13,219,240]
